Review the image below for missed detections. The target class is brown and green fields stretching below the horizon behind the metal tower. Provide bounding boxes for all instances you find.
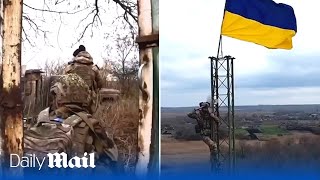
[161,106,320,174]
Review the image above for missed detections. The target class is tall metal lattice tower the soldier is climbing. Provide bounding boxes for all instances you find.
[209,56,236,173]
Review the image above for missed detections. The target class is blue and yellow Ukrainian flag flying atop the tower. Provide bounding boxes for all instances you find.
[221,0,297,49]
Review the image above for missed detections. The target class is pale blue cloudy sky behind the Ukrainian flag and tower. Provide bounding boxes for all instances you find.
[160,0,320,107]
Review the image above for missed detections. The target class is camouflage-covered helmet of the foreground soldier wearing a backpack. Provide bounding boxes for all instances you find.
[50,73,91,107]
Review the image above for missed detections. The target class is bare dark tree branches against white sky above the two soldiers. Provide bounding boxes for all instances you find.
[23,0,138,45]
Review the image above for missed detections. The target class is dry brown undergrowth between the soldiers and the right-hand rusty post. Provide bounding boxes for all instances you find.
[94,97,139,173]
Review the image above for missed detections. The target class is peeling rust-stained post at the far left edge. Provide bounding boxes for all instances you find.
[0,0,23,176]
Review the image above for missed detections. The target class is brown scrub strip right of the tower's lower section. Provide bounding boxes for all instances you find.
[236,135,320,168]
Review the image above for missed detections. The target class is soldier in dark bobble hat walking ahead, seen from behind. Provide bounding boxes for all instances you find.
[64,45,105,113]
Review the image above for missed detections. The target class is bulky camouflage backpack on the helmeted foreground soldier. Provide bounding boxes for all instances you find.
[24,108,118,162]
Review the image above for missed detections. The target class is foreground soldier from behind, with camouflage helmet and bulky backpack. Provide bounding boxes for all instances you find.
[24,74,118,173]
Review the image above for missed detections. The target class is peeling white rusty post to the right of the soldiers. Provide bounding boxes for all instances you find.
[136,0,153,177]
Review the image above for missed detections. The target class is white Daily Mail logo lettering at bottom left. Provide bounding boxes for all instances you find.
[10,152,96,170]
